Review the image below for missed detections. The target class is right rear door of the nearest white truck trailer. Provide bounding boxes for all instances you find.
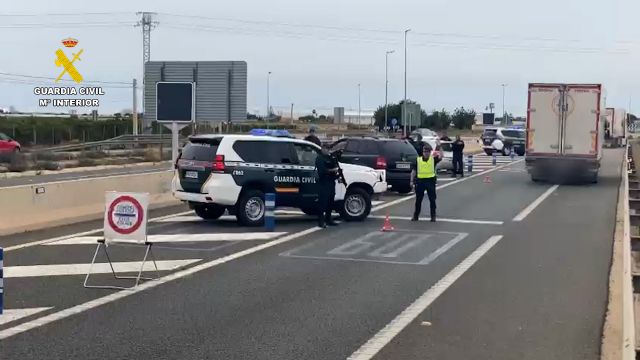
[562,85,601,155]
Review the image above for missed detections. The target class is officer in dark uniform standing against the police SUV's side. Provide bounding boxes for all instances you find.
[316,149,339,228]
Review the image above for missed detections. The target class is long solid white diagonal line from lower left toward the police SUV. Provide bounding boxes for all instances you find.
[0,227,321,340]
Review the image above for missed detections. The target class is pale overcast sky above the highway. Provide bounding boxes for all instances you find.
[0,0,640,115]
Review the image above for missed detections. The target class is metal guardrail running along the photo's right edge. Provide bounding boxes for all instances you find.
[622,145,640,360]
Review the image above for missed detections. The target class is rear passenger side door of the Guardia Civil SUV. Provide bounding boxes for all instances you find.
[267,141,302,206]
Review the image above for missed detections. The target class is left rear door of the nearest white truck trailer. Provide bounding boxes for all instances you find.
[527,84,562,155]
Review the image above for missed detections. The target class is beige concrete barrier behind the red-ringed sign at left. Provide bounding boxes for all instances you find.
[0,171,179,235]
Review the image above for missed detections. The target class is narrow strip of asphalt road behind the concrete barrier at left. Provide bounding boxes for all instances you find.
[0,164,169,187]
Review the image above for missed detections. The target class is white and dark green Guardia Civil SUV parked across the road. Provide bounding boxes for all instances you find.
[172,135,387,226]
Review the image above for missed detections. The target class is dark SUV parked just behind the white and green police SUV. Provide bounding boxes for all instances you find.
[330,137,418,194]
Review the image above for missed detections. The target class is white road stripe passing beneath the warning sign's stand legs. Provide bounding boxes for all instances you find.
[4,259,201,278]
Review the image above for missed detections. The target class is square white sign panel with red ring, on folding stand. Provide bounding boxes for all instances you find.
[104,191,149,242]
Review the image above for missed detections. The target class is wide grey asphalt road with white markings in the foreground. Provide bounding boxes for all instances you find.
[0,150,623,360]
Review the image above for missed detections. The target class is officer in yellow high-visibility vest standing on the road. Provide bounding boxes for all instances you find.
[411,144,441,222]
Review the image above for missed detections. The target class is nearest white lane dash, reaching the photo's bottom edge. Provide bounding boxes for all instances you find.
[348,235,502,360]
